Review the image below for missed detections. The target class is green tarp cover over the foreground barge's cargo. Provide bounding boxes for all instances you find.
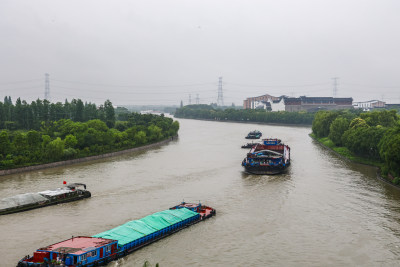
[93,208,198,246]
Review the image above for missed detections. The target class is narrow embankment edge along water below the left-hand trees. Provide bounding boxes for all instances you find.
[0,136,178,176]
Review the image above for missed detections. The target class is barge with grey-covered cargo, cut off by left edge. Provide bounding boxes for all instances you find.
[0,183,91,215]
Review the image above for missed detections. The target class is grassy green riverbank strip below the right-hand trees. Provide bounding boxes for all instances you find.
[309,133,400,189]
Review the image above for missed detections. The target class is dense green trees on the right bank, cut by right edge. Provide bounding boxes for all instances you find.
[312,110,400,180]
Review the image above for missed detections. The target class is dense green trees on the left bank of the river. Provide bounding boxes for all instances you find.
[0,100,179,169]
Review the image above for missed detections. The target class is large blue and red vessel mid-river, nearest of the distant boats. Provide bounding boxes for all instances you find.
[242,138,290,174]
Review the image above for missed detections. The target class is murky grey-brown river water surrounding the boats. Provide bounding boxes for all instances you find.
[0,119,400,267]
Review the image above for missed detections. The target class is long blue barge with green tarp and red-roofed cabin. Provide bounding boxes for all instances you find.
[17,202,216,267]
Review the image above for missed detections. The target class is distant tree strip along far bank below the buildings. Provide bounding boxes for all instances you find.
[175,105,314,124]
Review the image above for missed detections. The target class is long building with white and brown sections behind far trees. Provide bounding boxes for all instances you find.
[243,95,353,112]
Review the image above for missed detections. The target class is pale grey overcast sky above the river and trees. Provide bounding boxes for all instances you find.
[0,0,400,105]
